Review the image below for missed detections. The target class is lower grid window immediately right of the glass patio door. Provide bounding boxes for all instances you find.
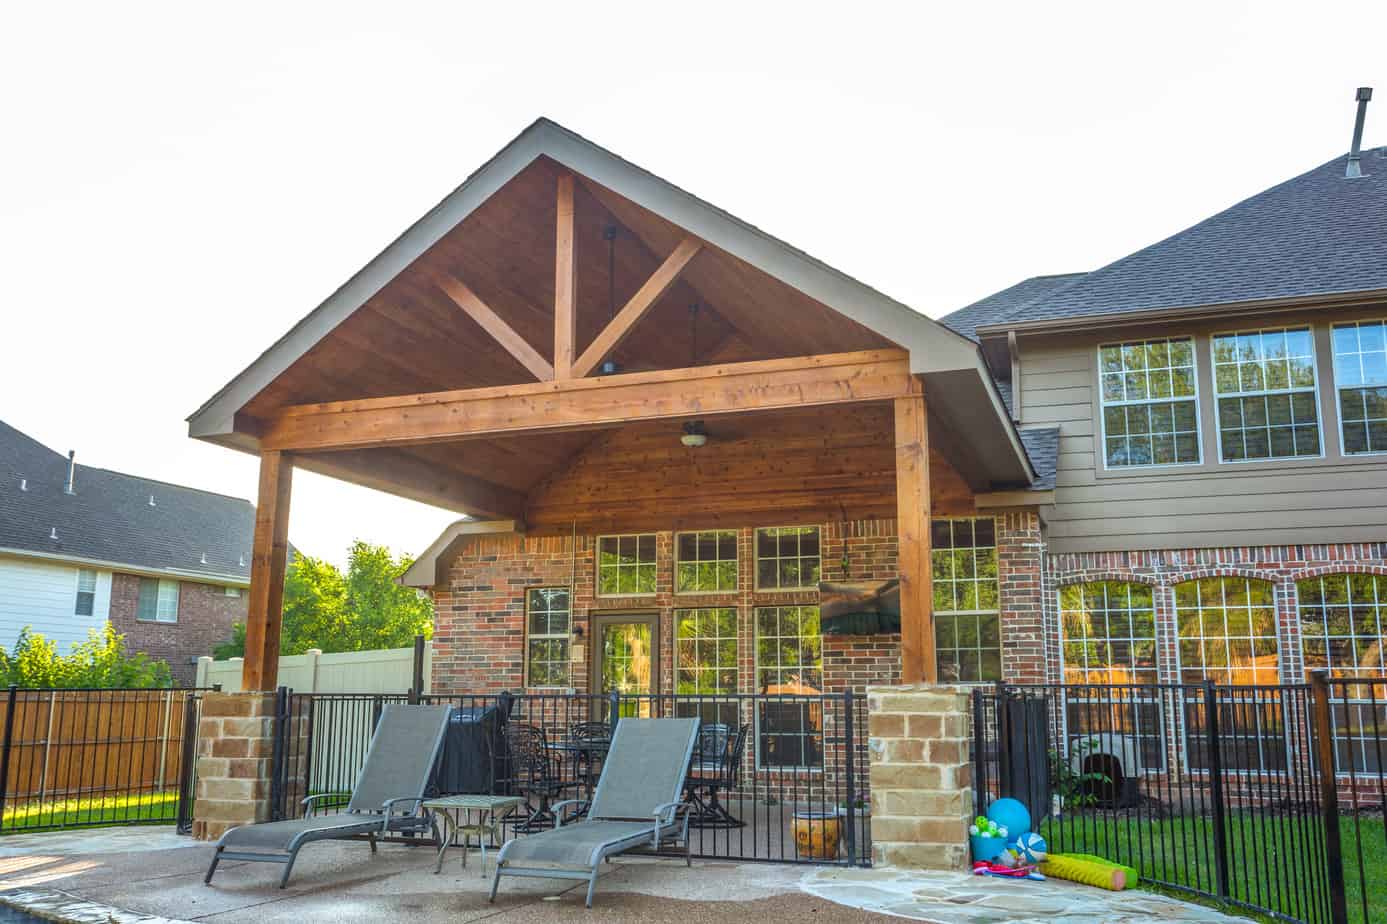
[674,606,738,730]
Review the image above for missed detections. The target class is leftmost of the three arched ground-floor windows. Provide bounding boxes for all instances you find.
[1060,581,1157,684]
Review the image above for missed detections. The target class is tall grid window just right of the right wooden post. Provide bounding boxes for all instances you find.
[931,517,1001,681]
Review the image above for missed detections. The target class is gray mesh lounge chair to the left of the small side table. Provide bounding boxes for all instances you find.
[203,705,452,888]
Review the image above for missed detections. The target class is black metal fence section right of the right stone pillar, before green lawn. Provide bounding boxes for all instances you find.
[974,676,1387,924]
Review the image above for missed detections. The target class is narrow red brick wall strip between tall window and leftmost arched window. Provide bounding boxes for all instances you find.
[997,511,1046,684]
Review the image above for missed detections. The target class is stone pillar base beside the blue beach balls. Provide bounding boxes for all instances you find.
[867,684,972,870]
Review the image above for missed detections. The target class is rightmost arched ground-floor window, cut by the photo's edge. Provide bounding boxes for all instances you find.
[1295,574,1387,677]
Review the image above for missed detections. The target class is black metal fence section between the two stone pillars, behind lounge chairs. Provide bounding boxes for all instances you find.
[270,690,871,866]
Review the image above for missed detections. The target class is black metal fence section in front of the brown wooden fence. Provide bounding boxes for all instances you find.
[0,687,203,834]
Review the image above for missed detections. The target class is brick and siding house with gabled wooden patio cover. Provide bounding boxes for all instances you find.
[190,104,1387,767]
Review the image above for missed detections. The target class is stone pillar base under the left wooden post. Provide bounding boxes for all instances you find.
[193,692,275,841]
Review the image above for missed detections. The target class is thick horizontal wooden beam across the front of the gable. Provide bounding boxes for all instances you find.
[261,350,913,451]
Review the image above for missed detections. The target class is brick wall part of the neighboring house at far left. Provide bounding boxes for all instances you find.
[111,573,248,687]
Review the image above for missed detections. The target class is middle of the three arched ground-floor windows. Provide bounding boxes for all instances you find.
[1175,577,1280,685]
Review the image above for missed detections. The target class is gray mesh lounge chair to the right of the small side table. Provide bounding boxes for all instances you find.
[490,719,699,907]
